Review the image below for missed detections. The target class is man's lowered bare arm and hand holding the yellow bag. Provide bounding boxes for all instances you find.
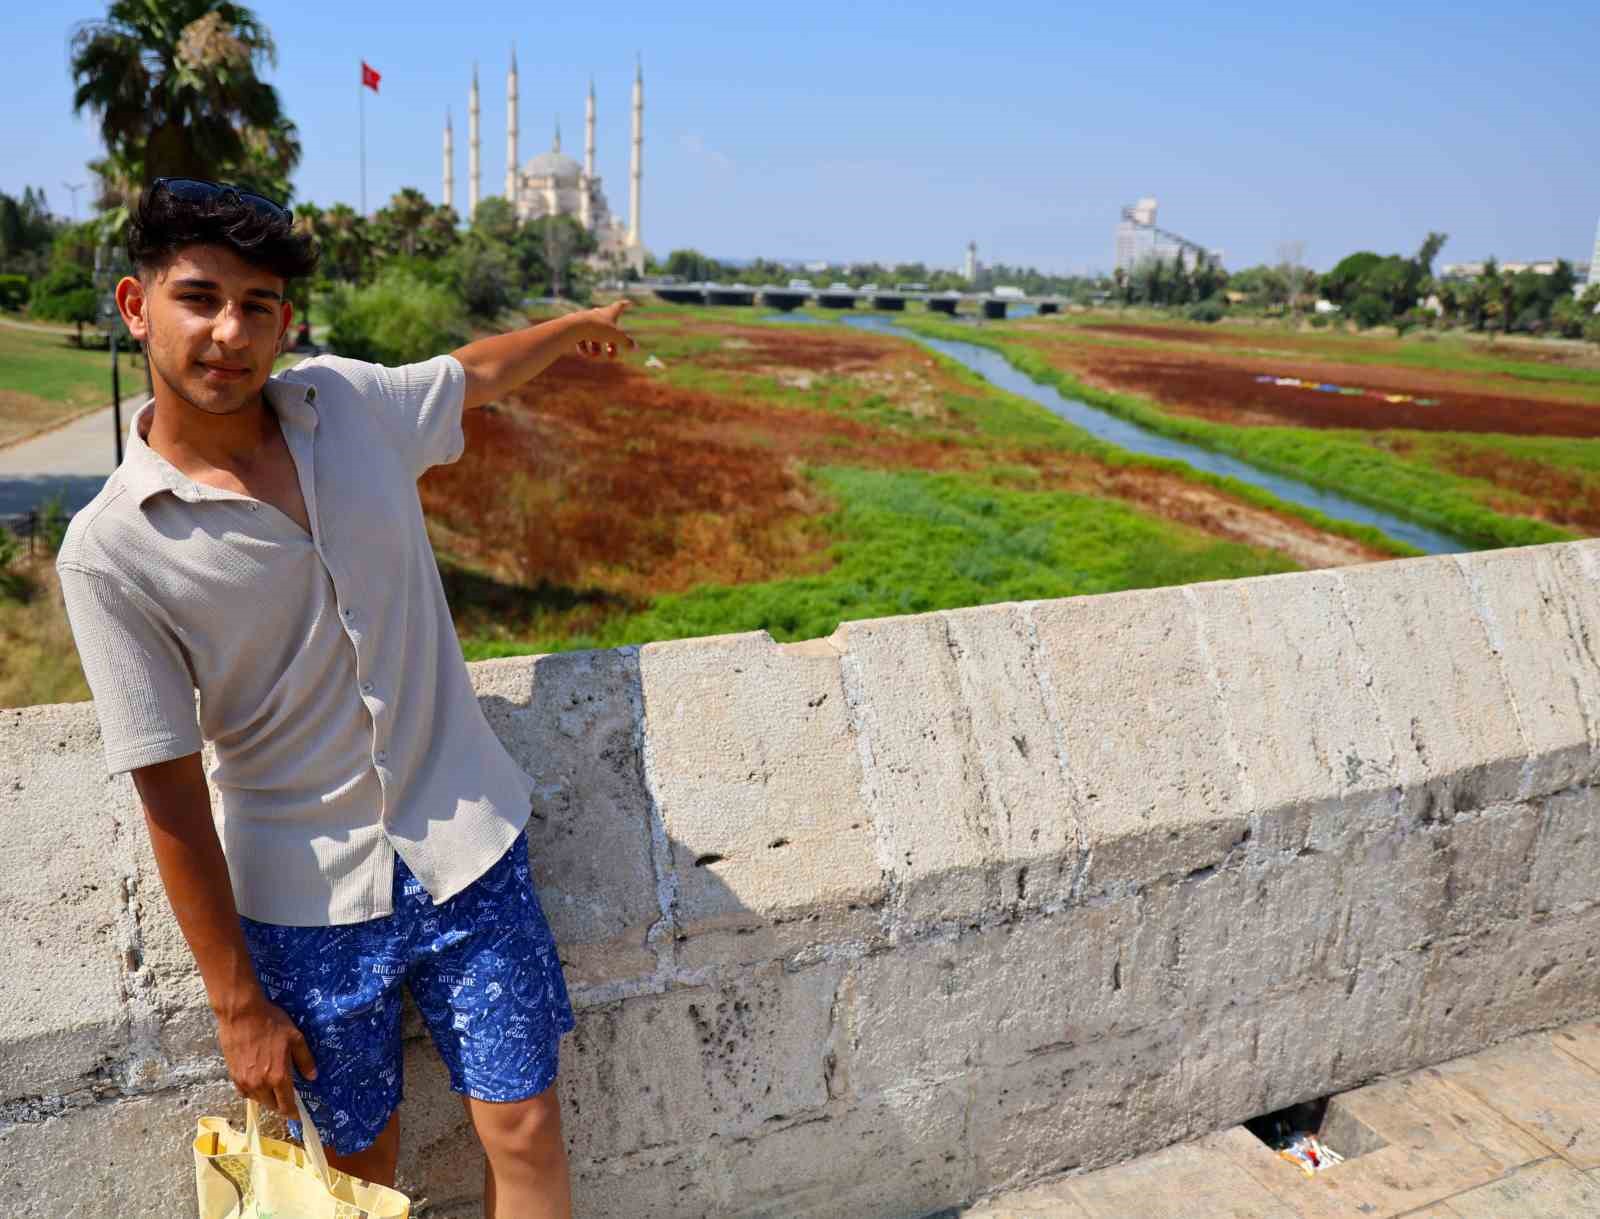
[133,753,317,1117]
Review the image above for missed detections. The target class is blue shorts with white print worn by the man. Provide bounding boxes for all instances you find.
[240,833,573,1155]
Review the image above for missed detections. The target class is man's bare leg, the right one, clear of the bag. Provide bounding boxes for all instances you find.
[466,1083,573,1219]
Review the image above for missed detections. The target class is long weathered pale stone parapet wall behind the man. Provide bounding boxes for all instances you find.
[0,542,1600,1219]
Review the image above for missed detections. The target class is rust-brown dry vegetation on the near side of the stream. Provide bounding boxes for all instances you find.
[421,318,1384,633]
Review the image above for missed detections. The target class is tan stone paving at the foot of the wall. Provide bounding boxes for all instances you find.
[960,1024,1600,1219]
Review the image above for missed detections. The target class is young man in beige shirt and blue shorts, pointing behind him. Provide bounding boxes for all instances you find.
[58,179,632,1219]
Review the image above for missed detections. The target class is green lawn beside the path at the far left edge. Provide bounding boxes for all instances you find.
[0,326,144,445]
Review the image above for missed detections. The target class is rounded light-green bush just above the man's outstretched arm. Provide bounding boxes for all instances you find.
[325,269,467,365]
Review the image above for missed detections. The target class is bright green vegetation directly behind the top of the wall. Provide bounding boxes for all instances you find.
[464,466,1296,661]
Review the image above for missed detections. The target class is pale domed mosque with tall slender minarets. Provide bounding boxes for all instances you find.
[443,48,645,275]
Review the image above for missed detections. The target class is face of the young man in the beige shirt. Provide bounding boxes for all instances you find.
[117,245,294,414]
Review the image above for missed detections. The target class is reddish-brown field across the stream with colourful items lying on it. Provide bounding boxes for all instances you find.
[1051,346,1600,437]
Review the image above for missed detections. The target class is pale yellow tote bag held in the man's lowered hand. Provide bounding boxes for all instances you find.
[194,1097,411,1219]
